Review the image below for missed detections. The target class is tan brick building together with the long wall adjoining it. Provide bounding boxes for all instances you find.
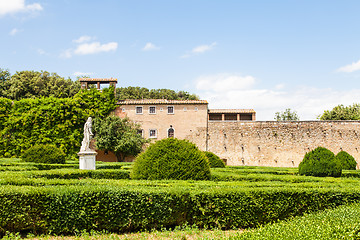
[97,99,360,167]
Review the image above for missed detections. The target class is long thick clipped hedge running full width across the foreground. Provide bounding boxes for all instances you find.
[0,186,360,235]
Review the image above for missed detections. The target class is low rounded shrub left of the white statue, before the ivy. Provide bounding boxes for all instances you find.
[22,144,66,163]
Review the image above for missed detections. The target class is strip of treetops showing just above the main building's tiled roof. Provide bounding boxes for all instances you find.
[116,87,198,100]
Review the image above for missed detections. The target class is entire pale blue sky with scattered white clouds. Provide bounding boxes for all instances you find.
[0,0,360,120]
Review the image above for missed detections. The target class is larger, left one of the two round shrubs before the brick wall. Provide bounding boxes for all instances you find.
[299,147,342,177]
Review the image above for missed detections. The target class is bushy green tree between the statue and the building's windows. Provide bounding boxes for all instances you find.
[94,115,147,162]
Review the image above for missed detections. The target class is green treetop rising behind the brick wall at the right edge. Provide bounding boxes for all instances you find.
[318,103,360,120]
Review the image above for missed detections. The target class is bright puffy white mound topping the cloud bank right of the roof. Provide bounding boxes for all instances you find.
[196,73,255,92]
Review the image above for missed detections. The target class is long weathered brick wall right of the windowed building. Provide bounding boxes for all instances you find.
[204,121,360,167]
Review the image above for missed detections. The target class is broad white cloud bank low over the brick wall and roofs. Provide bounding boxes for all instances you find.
[195,71,360,120]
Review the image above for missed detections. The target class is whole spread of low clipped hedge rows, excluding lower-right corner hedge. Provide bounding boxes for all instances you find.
[0,159,360,236]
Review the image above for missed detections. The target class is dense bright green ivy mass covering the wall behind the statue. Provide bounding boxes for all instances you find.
[0,88,115,157]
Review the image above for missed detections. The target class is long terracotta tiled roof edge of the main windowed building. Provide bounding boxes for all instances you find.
[117,99,208,105]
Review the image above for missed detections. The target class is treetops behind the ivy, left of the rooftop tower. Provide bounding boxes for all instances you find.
[3,71,80,100]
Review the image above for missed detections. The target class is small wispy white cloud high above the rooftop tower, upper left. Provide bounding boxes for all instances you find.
[60,36,118,58]
